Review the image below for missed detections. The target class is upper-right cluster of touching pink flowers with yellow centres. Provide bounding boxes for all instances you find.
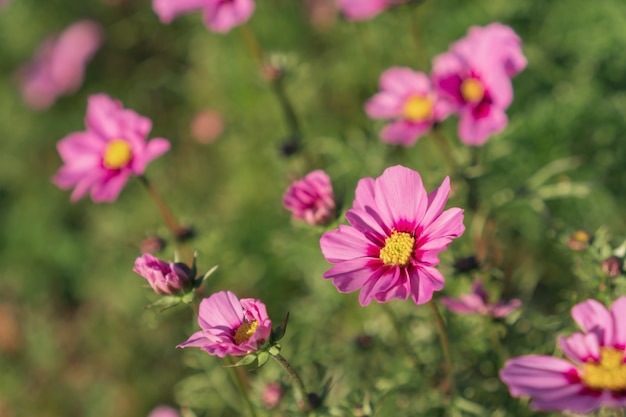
[365,23,526,146]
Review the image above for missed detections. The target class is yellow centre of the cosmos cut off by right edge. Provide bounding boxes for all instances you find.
[581,347,626,391]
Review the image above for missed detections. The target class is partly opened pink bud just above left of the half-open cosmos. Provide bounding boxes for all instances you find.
[133,253,194,295]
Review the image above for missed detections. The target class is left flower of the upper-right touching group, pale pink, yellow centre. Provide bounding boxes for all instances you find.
[365,67,451,146]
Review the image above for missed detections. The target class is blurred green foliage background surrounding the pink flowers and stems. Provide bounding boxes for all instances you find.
[0,0,626,417]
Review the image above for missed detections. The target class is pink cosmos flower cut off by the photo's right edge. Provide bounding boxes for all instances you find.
[500,297,626,414]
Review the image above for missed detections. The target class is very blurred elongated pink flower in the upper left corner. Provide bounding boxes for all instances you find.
[17,20,104,110]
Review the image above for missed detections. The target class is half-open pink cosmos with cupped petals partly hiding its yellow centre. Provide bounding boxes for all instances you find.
[178,291,272,358]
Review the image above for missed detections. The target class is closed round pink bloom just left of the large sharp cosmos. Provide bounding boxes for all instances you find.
[283,169,335,225]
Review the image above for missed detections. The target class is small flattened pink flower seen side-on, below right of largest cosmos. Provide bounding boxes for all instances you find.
[441,279,522,318]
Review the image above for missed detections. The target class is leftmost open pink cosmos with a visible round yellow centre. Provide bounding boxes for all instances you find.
[52,94,170,203]
